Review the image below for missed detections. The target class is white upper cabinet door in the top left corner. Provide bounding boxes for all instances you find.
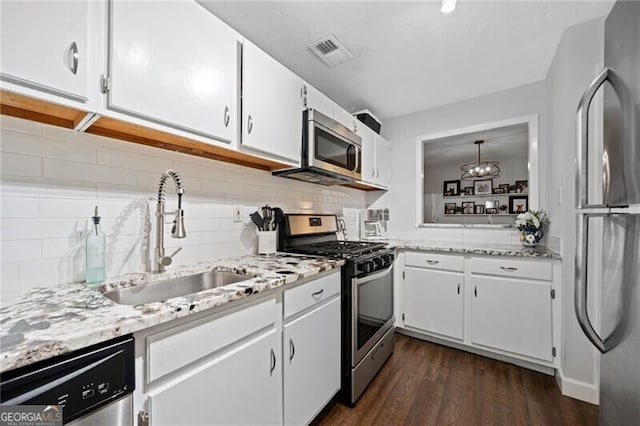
[0,0,88,102]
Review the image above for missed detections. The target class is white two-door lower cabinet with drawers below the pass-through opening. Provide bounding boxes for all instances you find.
[397,251,561,371]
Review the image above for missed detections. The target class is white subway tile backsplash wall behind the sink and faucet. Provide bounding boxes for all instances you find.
[0,116,366,304]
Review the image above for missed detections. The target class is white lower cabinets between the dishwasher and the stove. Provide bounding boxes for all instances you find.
[134,270,341,426]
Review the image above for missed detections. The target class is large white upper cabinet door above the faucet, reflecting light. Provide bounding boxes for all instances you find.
[108,1,237,142]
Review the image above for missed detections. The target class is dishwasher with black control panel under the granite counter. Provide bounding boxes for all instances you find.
[0,336,135,426]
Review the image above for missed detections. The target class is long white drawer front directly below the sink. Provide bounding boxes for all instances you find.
[147,299,278,382]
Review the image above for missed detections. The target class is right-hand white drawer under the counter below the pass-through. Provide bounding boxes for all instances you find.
[469,257,552,281]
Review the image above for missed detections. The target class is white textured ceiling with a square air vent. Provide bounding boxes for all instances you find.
[199,0,613,119]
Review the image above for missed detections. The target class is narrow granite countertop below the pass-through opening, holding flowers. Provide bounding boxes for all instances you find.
[389,239,561,259]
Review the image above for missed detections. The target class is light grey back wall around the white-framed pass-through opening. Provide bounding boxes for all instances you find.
[368,82,546,244]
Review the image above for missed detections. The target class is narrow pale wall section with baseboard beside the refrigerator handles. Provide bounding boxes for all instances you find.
[543,15,604,395]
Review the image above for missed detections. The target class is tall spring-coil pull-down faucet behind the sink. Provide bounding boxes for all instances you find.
[154,169,187,272]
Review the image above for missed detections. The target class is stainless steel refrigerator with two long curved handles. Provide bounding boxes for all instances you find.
[574,1,640,425]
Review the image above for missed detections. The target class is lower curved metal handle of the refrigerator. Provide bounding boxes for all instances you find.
[573,214,612,353]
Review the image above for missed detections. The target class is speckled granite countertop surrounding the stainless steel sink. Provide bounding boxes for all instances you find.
[0,254,344,371]
